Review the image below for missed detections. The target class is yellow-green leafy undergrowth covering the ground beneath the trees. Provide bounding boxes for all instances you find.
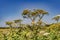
[0,23,60,40]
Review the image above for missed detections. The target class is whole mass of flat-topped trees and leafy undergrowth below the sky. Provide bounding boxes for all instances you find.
[0,9,60,40]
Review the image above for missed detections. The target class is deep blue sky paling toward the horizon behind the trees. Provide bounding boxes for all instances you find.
[0,0,60,27]
